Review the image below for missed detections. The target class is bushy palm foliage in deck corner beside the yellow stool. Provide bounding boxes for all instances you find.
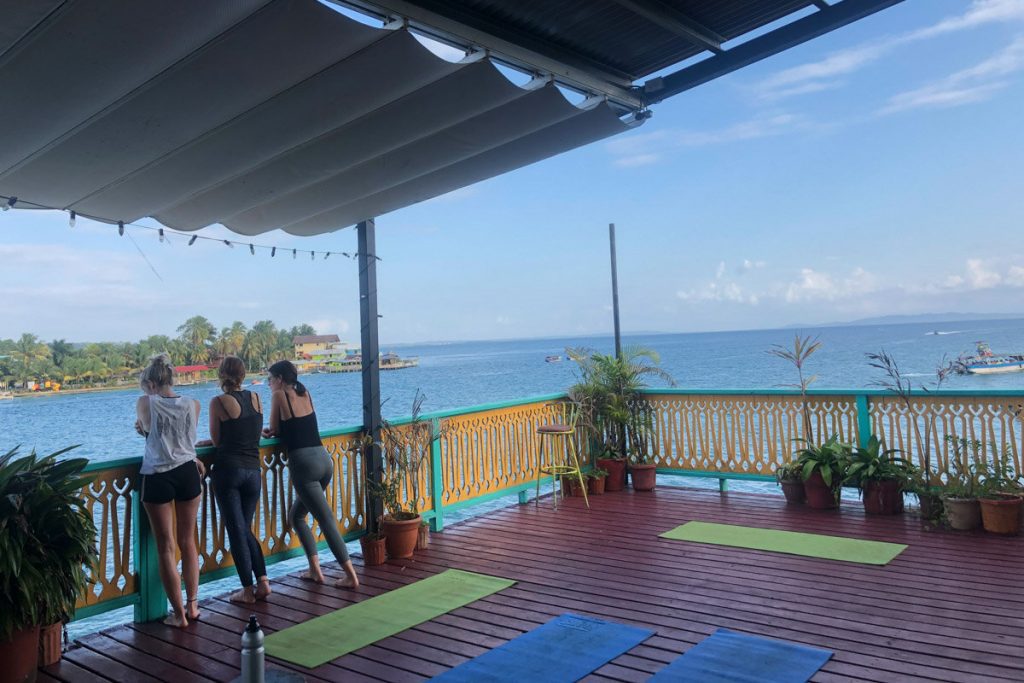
[565,346,675,463]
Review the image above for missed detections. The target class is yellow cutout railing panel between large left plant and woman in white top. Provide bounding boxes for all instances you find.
[76,465,138,608]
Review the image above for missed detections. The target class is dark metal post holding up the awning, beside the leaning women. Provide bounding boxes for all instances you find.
[355,218,384,531]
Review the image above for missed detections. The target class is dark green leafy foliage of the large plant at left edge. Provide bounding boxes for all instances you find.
[0,446,96,638]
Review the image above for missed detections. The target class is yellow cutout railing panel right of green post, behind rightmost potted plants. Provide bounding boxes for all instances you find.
[870,395,1024,483]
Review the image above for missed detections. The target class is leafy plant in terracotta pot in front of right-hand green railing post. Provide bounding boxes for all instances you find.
[844,434,918,515]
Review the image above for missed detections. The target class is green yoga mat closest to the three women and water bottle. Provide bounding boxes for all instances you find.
[263,569,515,669]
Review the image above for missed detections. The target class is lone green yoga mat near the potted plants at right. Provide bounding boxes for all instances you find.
[659,522,906,564]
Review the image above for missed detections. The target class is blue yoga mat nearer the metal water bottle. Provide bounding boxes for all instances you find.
[431,614,654,683]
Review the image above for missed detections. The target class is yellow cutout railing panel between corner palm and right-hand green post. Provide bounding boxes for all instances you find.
[647,393,858,475]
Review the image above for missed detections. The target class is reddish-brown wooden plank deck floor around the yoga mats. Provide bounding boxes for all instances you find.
[40,487,1024,683]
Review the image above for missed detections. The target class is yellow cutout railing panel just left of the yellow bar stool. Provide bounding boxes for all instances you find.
[440,401,559,505]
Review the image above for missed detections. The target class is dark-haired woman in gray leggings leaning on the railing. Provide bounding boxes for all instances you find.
[263,360,359,588]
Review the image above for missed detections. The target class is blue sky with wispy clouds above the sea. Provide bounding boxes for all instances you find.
[0,0,1024,343]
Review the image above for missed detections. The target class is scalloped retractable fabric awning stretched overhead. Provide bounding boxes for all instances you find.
[0,0,638,234]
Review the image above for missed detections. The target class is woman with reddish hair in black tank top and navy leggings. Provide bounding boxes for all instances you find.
[194,355,270,603]
